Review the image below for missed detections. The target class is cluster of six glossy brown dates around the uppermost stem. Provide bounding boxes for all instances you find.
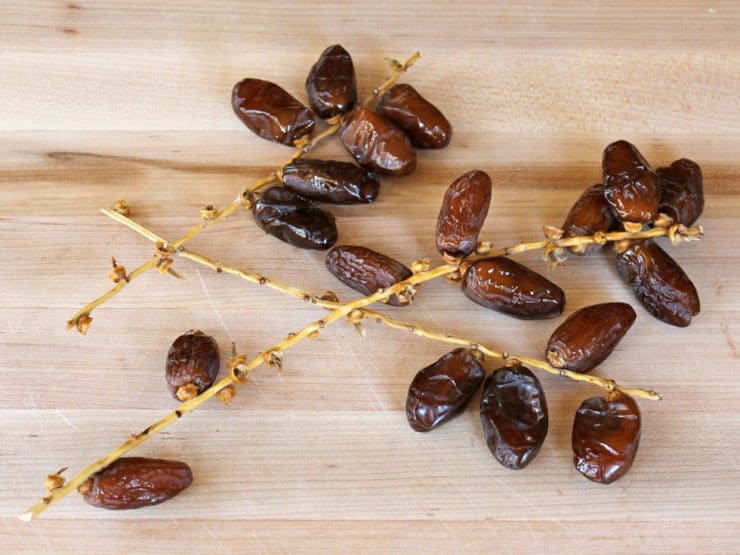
[232,45,452,250]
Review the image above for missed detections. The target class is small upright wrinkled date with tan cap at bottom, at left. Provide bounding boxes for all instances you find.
[165,330,221,401]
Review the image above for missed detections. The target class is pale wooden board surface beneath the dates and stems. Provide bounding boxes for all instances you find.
[0,0,740,553]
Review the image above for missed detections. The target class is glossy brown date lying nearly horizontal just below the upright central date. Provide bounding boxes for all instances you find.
[462,257,565,320]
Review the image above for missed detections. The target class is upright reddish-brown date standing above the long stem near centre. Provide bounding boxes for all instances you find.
[437,170,492,258]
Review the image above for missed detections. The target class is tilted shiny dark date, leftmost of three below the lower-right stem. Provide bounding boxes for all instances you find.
[406,348,485,432]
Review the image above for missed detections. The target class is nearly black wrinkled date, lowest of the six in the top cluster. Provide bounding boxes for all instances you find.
[254,187,337,250]
